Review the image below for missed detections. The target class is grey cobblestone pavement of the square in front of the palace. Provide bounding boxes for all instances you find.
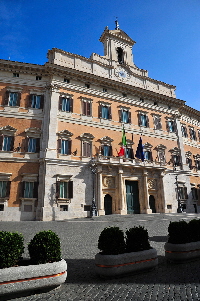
[0,214,200,301]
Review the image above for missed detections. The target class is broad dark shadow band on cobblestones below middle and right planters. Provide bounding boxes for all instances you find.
[66,256,200,284]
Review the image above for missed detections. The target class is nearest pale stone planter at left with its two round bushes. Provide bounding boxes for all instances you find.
[0,230,67,295]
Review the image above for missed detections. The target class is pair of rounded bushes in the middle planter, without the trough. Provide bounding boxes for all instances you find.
[98,226,151,255]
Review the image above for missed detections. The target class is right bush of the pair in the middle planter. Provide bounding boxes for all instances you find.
[126,226,151,252]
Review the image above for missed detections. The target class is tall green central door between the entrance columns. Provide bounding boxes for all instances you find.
[125,181,140,214]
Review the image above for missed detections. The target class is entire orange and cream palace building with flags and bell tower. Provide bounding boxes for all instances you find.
[0,22,200,221]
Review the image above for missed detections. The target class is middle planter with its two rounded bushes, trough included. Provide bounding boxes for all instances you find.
[95,226,158,277]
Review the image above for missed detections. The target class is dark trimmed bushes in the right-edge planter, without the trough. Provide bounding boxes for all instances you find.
[168,219,200,244]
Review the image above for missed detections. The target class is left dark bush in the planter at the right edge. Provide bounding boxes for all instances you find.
[168,220,190,244]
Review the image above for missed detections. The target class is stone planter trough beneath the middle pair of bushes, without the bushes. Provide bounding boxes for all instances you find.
[95,248,158,277]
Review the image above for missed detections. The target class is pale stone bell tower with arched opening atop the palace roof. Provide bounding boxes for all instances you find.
[99,20,135,66]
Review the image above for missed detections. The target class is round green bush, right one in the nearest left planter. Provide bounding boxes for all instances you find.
[28,230,61,264]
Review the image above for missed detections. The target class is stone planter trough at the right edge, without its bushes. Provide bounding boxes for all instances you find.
[165,241,200,262]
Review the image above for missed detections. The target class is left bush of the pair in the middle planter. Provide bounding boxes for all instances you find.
[98,227,126,255]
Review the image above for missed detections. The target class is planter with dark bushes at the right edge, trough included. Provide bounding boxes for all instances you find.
[165,219,200,262]
